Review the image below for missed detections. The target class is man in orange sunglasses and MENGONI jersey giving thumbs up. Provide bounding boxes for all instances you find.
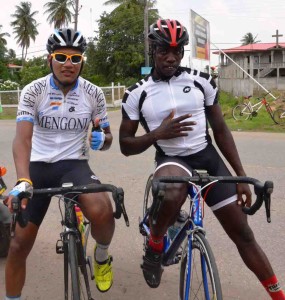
[6,28,115,300]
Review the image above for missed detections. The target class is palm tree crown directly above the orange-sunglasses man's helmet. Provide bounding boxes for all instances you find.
[44,0,73,28]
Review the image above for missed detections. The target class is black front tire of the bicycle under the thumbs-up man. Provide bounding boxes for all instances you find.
[64,234,81,300]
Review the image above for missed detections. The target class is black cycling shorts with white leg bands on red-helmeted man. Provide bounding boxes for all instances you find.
[155,144,237,211]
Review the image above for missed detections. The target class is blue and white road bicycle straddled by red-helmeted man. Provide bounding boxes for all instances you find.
[139,170,273,300]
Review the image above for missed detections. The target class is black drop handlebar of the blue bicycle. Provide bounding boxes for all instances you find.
[152,173,273,223]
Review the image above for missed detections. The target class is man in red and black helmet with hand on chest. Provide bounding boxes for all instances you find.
[119,20,285,299]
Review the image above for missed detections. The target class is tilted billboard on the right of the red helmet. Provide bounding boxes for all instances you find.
[190,10,210,60]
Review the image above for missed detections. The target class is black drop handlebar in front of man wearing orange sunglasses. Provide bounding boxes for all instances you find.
[11,183,130,236]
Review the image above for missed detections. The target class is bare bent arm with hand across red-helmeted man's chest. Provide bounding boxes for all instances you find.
[119,111,196,156]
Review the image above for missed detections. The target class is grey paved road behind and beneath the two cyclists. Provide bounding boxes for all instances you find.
[0,112,285,300]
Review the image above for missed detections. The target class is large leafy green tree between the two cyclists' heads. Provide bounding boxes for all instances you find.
[93,0,157,82]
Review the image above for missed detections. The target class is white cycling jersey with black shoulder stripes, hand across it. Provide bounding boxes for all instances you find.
[122,67,218,156]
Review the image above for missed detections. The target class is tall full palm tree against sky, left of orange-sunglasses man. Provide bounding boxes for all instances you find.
[10,2,39,64]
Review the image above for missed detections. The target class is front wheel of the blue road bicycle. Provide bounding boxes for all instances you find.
[179,232,223,300]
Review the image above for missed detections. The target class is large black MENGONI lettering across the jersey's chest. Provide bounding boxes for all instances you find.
[39,116,90,131]
